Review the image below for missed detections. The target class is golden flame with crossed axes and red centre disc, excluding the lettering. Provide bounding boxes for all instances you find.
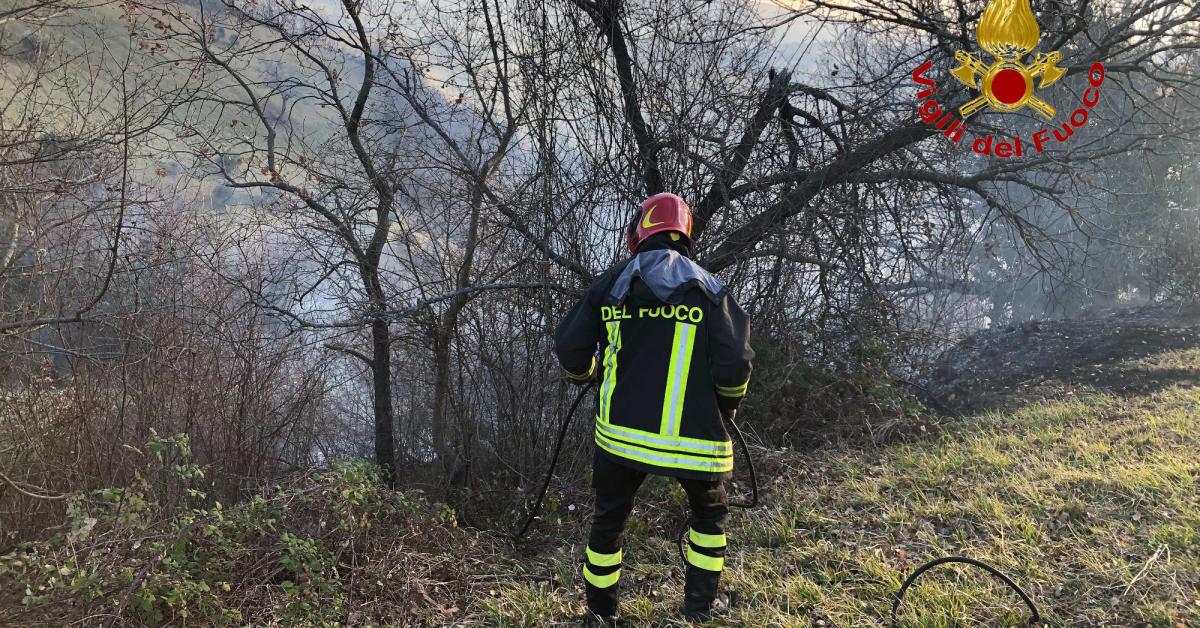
[950,0,1067,120]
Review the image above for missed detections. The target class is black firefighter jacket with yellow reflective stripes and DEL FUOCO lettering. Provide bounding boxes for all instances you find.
[554,234,754,479]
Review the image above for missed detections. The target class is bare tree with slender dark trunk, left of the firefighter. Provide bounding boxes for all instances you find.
[146,1,422,482]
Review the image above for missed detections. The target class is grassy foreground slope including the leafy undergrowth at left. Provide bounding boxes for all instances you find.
[0,323,1200,628]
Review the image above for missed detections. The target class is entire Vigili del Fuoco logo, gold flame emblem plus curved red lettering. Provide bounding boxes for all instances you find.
[912,0,1104,157]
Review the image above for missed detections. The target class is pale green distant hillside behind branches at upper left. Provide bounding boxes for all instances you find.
[0,2,350,204]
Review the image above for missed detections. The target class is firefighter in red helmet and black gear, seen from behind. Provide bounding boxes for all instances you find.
[554,193,754,626]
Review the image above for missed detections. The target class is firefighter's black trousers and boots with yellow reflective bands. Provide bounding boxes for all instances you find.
[583,451,730,616]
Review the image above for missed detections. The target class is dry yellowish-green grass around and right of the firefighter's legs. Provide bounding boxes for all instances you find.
[468,351,1200,628]
